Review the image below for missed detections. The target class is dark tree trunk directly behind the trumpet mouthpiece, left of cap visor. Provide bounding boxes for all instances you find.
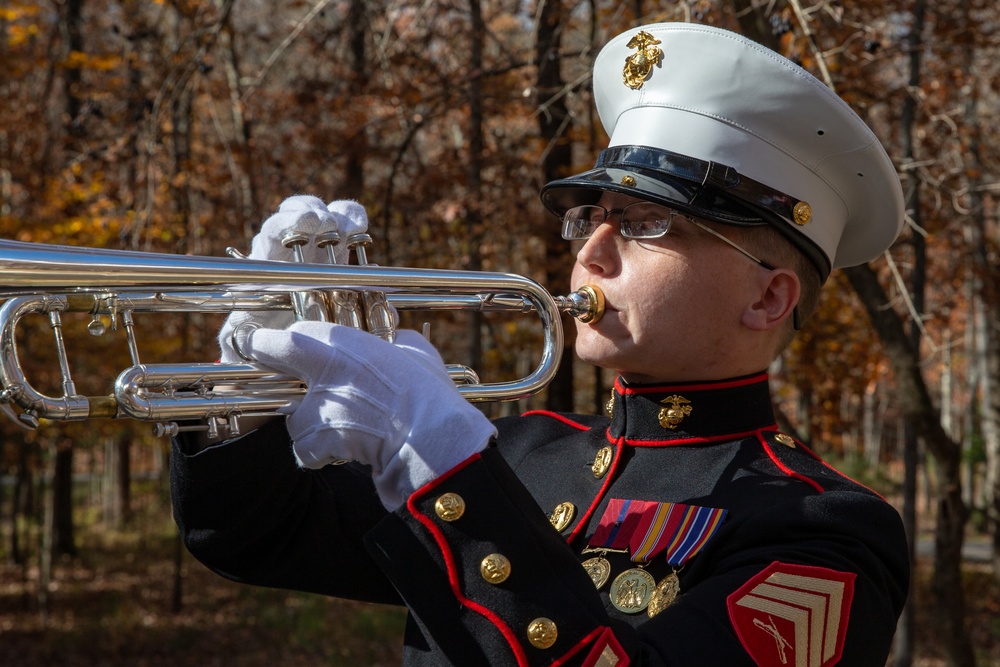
[535,0,575,411]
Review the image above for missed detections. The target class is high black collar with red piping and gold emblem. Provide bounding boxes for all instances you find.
[608,372,774,446]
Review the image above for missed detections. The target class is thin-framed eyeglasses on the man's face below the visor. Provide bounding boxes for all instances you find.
[563,202,775,271]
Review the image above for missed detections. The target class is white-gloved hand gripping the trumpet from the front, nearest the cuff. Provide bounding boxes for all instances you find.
[244,322,496,510]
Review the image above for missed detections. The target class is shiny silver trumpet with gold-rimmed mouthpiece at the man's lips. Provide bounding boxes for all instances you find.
[0,232,604,437]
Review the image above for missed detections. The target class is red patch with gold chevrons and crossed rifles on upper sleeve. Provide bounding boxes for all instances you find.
[727,561,856,667]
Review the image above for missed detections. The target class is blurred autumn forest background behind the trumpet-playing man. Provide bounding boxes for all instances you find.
[0,0,1000,666]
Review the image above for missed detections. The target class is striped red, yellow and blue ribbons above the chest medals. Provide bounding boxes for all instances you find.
[589,498,727,567]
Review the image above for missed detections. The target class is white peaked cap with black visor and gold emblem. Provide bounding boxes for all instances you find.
[541,23,904,279]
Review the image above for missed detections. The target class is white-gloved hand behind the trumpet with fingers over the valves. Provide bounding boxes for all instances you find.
[219,195,368,363]
